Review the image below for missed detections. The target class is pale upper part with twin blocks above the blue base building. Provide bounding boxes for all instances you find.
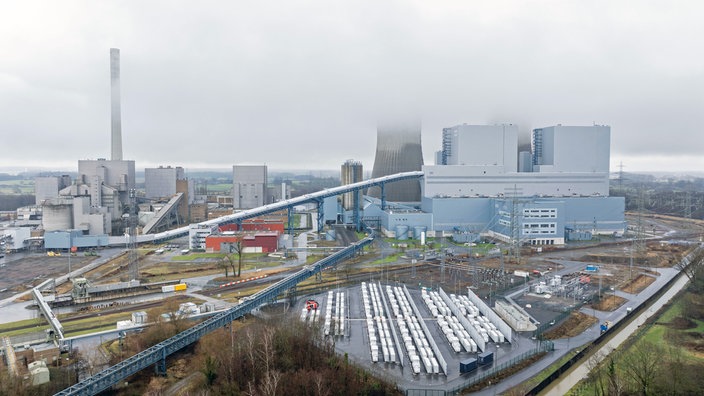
[422,124,611,198]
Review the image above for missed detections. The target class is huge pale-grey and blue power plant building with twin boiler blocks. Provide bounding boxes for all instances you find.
[365,124,625,245]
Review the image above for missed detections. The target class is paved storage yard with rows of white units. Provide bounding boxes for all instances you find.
[300,282,536,385]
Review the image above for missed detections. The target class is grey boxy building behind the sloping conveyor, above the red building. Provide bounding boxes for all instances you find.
[232,165,269,209]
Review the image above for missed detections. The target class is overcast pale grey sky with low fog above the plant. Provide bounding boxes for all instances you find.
[0,0,704,175]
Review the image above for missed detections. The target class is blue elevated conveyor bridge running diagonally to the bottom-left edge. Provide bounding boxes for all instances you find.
[56,230,374,395]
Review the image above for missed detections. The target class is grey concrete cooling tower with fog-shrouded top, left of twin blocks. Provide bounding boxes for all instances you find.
[367,122,423,202]
